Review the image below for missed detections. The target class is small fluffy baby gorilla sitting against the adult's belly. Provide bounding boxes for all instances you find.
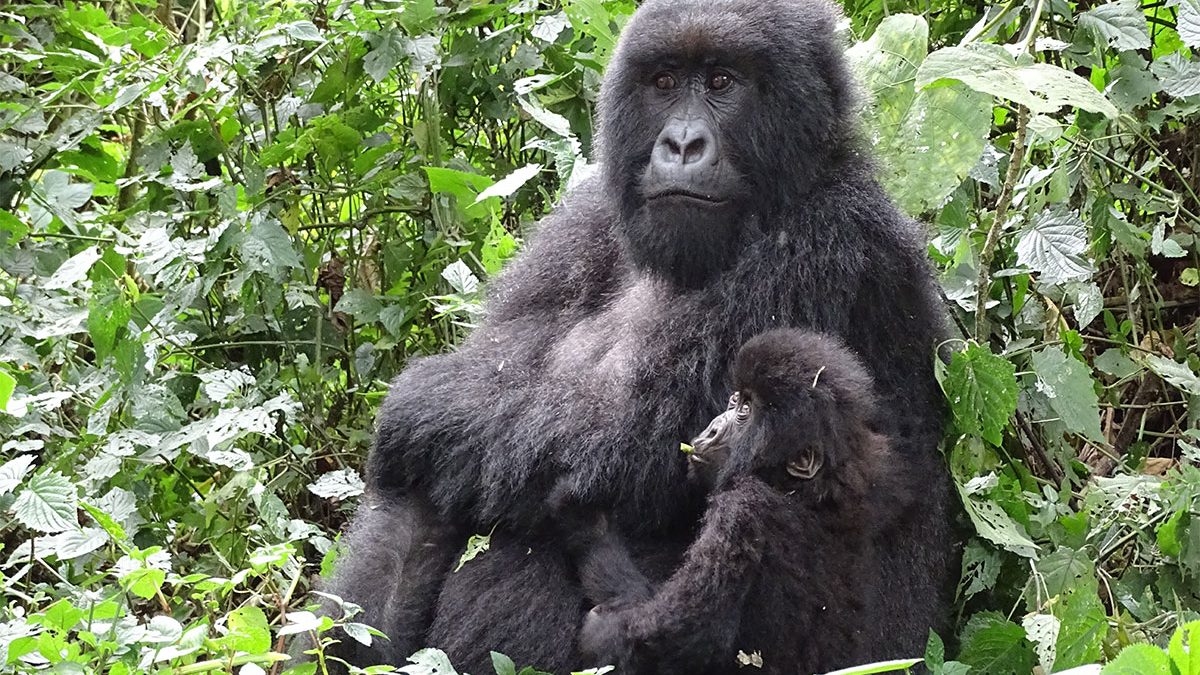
[559,330,908,674]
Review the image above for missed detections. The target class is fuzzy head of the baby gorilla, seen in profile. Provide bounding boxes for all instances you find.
[689,329,883,498]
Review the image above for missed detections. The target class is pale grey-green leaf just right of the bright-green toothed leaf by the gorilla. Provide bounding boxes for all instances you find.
[1032,347,1104,442]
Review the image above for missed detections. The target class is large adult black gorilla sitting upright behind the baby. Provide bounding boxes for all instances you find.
[331,0,953,673]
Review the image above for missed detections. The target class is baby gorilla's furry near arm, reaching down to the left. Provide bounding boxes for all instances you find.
[580,477,782,671]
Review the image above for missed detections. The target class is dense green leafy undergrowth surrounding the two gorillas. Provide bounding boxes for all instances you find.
[0,0,1200,675]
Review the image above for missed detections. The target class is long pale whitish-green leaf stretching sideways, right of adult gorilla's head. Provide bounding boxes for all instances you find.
[917,43,1118,118]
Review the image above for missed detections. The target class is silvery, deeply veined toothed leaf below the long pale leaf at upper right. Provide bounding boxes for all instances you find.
[1016,208,1093,283]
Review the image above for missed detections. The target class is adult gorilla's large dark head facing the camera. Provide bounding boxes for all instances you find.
[599,0,853,286]
